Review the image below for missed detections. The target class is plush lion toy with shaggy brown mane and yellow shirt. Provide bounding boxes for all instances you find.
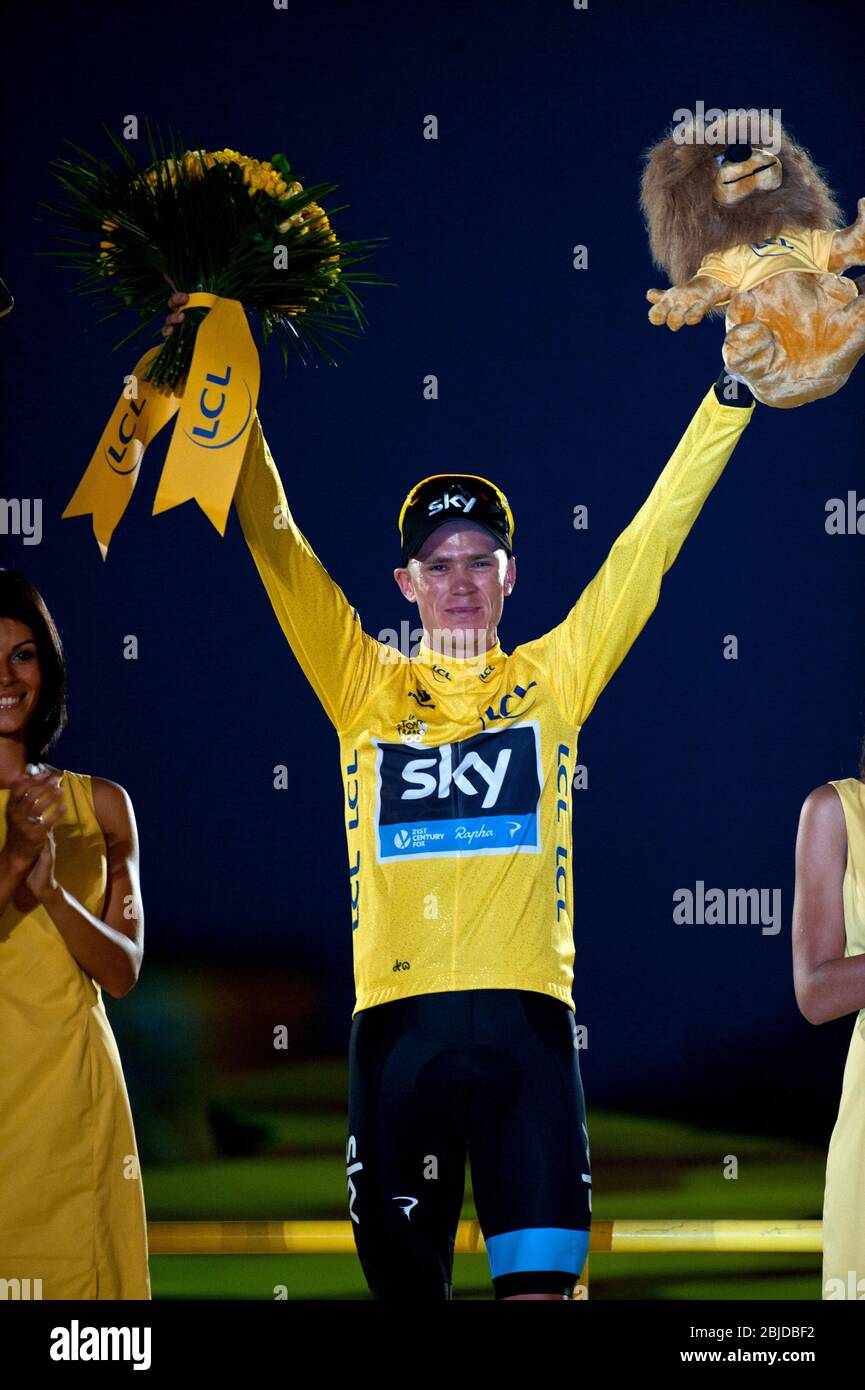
[640,117,865,409]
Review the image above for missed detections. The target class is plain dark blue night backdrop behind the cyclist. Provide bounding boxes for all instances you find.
[0,0,865,1137]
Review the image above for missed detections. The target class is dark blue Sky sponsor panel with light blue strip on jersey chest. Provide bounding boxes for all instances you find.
[373,720,544,863]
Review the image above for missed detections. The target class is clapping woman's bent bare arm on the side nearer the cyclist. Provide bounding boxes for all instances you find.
[28,777,145,999]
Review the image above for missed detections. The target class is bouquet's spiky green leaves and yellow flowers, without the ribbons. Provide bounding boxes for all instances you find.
[42,126,392,386]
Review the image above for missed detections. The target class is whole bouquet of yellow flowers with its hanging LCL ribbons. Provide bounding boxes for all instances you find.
[43,126,391,559]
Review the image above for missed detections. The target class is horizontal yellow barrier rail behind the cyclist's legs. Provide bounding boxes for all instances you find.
[147,1220,822,1255]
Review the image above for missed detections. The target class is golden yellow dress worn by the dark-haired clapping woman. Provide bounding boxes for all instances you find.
[0,771,150,1298]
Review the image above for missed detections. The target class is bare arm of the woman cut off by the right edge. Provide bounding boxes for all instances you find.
[793,784,865,1023]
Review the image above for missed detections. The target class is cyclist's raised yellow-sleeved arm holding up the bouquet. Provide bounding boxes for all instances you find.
[234,416,389,730]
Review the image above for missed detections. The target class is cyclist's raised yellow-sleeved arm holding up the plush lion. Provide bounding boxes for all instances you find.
[522,373,754,726]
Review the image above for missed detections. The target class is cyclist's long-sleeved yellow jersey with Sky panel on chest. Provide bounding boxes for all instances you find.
[235,388,754,1016]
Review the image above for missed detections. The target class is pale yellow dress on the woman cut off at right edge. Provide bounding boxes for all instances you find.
[823,777,865,1300]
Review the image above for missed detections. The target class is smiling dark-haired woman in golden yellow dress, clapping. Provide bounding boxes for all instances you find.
[0,570,150,1298]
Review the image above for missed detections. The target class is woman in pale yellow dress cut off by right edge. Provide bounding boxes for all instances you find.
[793,748,865,1300]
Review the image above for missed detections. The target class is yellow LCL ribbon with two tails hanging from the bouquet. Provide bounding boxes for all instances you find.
[63,292,261,560]
